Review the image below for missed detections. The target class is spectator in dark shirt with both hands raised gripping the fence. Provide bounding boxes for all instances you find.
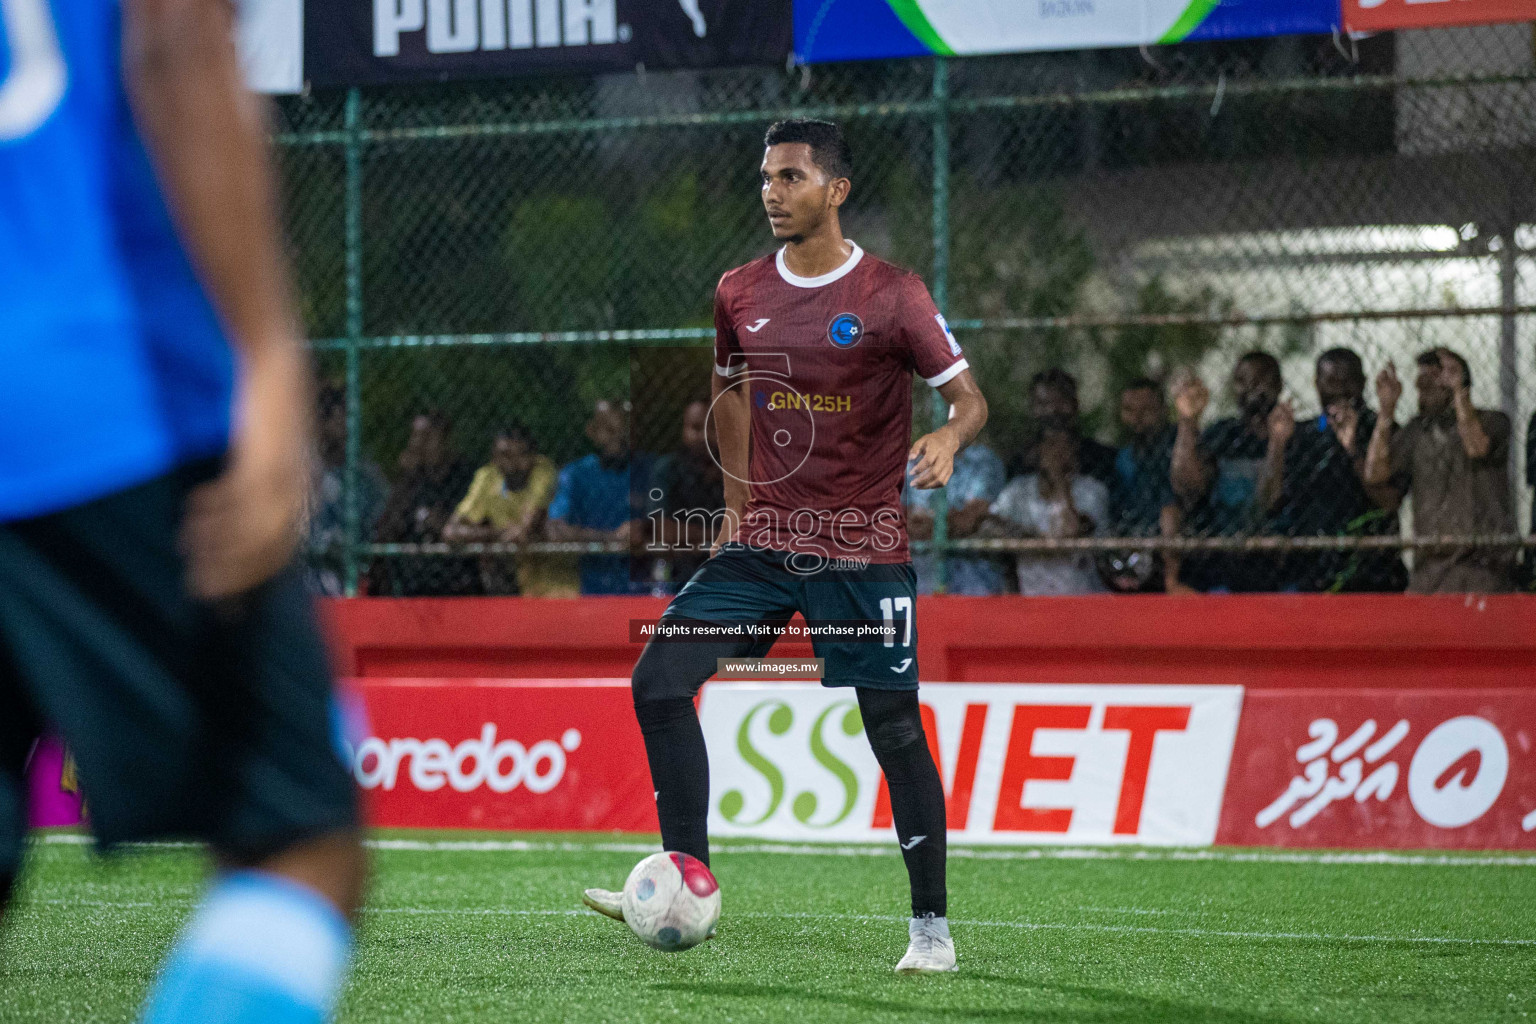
[1169,352,1296,593]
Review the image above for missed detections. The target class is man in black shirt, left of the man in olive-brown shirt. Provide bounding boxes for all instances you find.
[1266,348,1409,593]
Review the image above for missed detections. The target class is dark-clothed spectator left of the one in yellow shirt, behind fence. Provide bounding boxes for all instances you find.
[370,410,479,597]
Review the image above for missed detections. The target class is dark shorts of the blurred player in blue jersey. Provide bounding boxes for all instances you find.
[0,464,358,875]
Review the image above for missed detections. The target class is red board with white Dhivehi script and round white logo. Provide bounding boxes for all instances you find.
[1217,689,1536,849]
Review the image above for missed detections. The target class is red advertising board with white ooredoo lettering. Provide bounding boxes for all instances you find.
[349,679,656,832]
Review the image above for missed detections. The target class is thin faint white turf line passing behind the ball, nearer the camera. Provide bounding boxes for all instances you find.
[28,900,1536,946]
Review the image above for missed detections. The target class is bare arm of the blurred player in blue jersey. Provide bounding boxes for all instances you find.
[123,0,313,599]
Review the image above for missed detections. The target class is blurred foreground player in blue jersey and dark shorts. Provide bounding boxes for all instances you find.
[0,0,364,1024]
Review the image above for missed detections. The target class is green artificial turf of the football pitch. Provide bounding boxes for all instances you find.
[0,834,1536,1024]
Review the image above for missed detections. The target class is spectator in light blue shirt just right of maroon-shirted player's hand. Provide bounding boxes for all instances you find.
[903,438,1008,597]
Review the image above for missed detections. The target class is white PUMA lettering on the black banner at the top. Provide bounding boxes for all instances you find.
[373,0,630,57]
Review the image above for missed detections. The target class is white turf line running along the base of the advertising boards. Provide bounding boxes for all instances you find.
[37,834,1536,867]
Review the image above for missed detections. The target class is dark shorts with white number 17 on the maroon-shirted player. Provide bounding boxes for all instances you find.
[647,543,917,699]
